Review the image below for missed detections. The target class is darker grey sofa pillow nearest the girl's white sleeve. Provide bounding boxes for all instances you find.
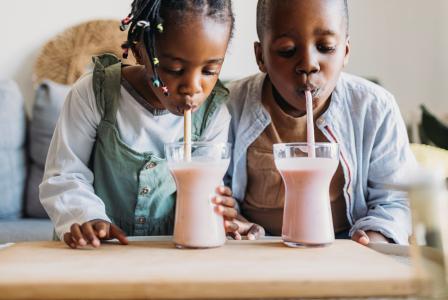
[25,80,71,218]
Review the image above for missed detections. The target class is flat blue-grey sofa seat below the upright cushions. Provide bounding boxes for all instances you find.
[0,219,53,244]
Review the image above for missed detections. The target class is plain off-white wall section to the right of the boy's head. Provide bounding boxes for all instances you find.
[347,0,448,119]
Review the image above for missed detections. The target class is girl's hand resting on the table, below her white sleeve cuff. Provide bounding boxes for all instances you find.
[64,220,128,249]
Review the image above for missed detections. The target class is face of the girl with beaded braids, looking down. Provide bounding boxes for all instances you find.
[139,15,230,115]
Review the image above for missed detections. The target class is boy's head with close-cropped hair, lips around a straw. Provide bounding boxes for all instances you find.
[255,0,350,116]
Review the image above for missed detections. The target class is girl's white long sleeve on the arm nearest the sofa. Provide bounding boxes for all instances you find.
[39,79,110,240]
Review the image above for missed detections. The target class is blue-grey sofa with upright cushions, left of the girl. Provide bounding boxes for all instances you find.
[0,80,70,244]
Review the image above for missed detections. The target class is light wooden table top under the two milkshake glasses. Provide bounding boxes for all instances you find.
[0,238,416,299]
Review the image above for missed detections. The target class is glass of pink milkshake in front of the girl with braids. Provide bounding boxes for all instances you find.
[165,142,231,248]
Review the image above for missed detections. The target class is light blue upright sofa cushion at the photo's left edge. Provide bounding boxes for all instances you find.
[0,80,26,219]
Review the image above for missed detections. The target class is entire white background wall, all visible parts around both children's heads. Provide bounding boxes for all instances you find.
[0,0,448,122]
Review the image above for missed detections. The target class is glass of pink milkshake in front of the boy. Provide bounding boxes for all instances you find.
[274,143,339,247]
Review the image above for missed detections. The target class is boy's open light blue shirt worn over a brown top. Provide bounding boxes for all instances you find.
[226,73,415,244]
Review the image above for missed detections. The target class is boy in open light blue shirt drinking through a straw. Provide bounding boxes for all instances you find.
[227,0,414,245]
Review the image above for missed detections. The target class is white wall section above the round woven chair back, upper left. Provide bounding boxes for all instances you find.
[0,0,130,115]
